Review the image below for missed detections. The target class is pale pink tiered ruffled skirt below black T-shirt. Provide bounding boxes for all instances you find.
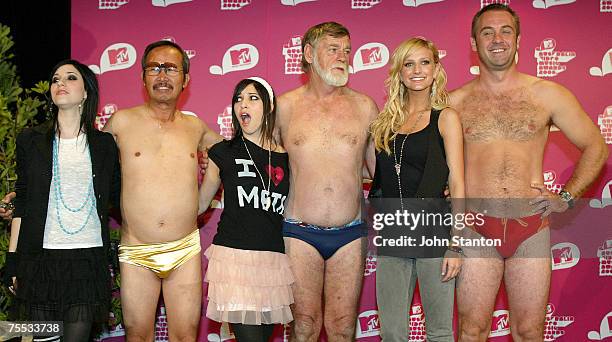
[204,245,294,325]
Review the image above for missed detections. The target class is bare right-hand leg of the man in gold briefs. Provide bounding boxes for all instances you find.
[162,253,202,342]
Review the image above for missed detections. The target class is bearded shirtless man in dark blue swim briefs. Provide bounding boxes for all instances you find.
[277,22,378,341]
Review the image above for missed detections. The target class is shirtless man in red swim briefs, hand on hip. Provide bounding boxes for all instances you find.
[451,4,608,342]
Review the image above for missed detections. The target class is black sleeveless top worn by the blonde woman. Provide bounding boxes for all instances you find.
[369,110,450,257]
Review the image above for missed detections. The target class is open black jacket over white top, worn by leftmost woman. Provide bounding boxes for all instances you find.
[14,122,121,254]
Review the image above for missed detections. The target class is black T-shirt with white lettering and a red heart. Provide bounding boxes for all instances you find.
[208,139,289,253]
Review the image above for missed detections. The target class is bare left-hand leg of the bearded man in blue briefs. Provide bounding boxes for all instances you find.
[284,237,325,342]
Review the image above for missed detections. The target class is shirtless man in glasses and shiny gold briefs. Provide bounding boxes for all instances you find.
[104,41,221,342]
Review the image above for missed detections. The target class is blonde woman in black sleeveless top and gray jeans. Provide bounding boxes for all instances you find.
[371,38,464,341]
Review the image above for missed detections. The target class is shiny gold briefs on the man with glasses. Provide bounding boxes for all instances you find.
[119,229,202,278]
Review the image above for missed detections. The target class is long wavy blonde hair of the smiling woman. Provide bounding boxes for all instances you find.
[370,37,449,154]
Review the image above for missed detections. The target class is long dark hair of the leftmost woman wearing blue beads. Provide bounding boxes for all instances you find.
[49,59,99,144]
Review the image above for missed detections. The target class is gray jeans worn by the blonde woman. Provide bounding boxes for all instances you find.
[376,255,455,342]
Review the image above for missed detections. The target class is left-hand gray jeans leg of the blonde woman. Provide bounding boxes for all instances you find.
[376,255,416,342]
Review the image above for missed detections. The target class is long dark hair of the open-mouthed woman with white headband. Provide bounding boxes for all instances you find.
[231,78,278,149]
